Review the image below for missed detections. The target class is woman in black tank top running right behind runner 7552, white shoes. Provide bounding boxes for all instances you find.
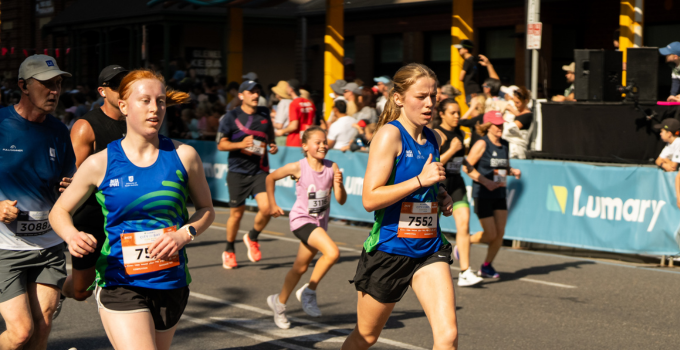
[435,98,482,287]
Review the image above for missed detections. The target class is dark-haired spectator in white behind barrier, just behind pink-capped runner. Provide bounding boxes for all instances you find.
[503,86,534,159]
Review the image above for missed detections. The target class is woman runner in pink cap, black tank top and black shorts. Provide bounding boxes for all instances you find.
[468,111,522,278]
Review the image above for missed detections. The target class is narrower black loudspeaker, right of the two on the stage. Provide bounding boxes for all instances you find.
[626,47,659,102]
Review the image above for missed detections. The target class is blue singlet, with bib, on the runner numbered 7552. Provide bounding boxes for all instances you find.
[364,120,448,258]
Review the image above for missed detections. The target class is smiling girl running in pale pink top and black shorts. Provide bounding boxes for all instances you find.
[267,126,347,329]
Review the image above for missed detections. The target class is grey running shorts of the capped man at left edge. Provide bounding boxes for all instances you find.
[0,243,66,303]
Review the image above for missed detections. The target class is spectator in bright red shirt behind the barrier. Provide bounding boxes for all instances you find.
[276,79,316,147]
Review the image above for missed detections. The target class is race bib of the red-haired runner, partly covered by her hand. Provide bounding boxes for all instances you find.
[120,226,179,275]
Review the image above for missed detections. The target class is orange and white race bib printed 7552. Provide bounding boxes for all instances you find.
[397,202,438,238]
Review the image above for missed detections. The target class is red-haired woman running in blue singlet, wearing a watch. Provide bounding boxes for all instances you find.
[50,70,215,349]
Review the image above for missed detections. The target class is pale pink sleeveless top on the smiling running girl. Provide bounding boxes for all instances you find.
[289,158,334,231]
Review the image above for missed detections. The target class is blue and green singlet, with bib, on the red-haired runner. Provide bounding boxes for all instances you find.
[95,135,191,289]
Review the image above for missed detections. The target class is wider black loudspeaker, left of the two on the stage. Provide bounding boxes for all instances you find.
[574,50,623,102]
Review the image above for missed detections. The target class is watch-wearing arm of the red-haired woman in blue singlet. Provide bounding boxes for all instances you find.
[149,141,215,259]
